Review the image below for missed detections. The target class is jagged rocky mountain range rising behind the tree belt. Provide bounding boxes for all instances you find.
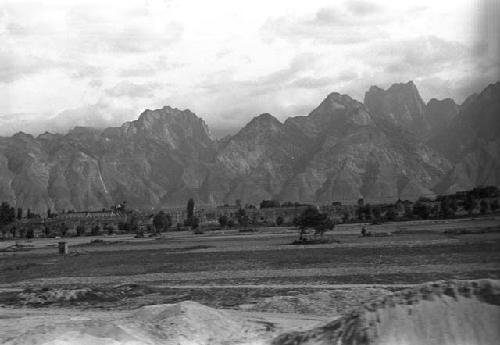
[0,82,500,212]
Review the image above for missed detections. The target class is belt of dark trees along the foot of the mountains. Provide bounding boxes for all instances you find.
[0,186,500,240]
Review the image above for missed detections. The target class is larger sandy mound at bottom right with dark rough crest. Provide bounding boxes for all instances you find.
[273,280,500,345]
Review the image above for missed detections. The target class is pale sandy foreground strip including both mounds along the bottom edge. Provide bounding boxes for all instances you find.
[0,279,500,345]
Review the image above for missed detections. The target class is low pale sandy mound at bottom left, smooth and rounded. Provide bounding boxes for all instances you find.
[5,302,265,345]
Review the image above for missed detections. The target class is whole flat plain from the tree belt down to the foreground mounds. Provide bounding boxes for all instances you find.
[0,217,500,340]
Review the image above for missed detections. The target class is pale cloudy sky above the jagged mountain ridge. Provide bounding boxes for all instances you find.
[0,0,500,136]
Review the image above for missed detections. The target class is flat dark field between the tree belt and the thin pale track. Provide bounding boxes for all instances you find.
[0,219,500,286]
